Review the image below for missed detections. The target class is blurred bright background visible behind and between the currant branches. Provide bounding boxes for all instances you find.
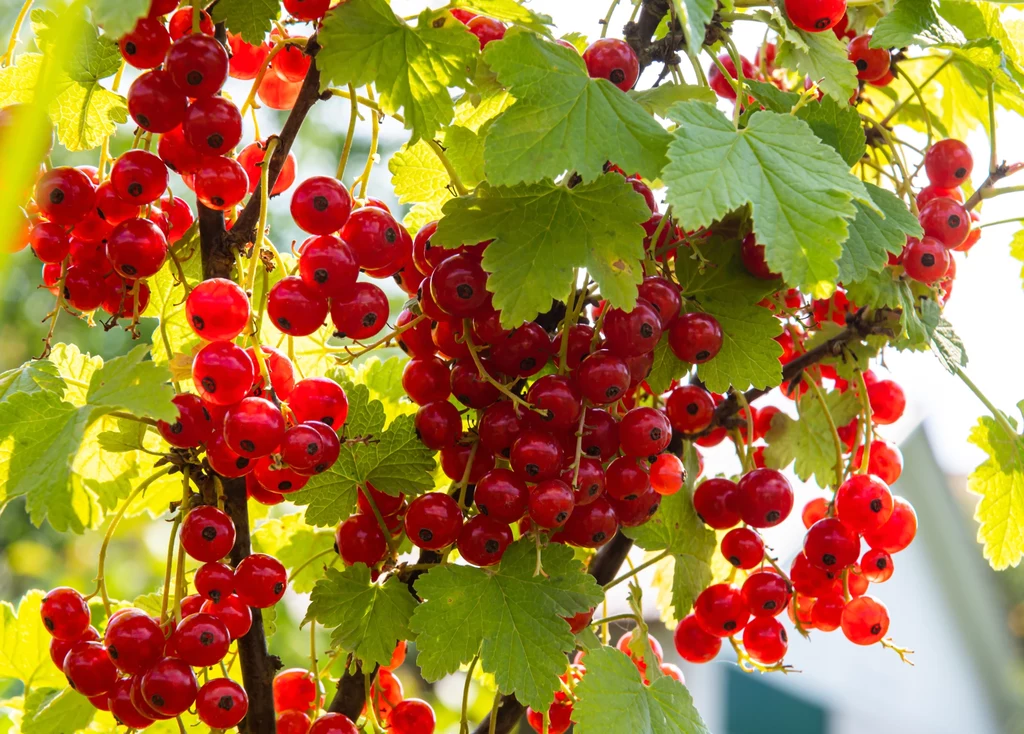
[0,0,1024,734]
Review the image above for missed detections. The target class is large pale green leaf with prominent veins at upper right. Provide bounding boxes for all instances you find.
[663,102,873,297]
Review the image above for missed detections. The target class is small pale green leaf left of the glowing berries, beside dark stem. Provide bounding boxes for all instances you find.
[87,344,177,421]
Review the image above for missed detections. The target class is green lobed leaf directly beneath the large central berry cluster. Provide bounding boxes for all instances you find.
[412,539,603,709]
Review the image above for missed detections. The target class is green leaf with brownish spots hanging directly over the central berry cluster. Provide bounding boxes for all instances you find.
[434,175,650,327]
